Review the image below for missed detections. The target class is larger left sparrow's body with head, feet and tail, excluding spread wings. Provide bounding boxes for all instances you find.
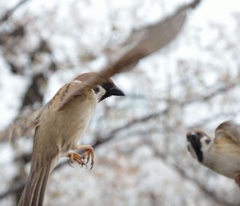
[18,72,124,206]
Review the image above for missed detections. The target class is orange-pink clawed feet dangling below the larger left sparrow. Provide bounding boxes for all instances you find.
[65,145,94,170]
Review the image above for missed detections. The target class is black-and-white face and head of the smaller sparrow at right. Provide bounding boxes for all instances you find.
[186,129,213,163]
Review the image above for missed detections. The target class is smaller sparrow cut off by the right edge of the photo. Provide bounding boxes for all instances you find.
[187,121,240,186]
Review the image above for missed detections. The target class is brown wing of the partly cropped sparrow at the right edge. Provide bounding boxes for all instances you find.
[215,121,240,146]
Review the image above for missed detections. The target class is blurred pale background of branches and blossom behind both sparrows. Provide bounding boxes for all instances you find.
[0,0,240,206]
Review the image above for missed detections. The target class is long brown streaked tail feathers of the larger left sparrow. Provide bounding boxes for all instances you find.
[18,162,51,206]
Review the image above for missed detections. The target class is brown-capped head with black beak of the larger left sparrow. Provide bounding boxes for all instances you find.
[75,72,125,102]
